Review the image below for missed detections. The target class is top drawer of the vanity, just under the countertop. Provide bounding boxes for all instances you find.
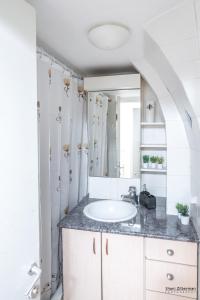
[145,238,197,266]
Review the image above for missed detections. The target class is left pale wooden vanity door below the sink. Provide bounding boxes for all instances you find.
[62,229,101,300]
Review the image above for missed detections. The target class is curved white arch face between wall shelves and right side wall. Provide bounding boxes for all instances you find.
[132,57,192,214]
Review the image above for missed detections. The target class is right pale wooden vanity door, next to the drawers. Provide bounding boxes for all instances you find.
[102,234,144,300]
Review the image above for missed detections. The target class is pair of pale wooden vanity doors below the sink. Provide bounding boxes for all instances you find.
[63,229,144,300]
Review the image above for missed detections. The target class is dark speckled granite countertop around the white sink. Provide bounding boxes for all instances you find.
[58,197,199,242]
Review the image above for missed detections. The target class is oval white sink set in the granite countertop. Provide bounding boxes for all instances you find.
[83,200,137,223]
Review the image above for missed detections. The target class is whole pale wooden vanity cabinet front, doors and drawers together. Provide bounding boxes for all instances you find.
[62,228,197,300]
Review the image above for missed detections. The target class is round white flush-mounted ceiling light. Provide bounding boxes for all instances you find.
[88,24,130,50]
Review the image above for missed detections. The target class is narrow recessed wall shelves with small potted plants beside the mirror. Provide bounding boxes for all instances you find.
[140,80,168,199]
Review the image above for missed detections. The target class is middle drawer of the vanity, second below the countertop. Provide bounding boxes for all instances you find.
[146,260,197,298]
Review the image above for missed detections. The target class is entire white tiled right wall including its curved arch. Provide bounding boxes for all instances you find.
[128,0,200,213]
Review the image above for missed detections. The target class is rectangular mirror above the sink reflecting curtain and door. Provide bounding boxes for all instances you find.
[88,89,141,178]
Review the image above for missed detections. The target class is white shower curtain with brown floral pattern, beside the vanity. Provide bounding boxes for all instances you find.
[38,49,88,300]
